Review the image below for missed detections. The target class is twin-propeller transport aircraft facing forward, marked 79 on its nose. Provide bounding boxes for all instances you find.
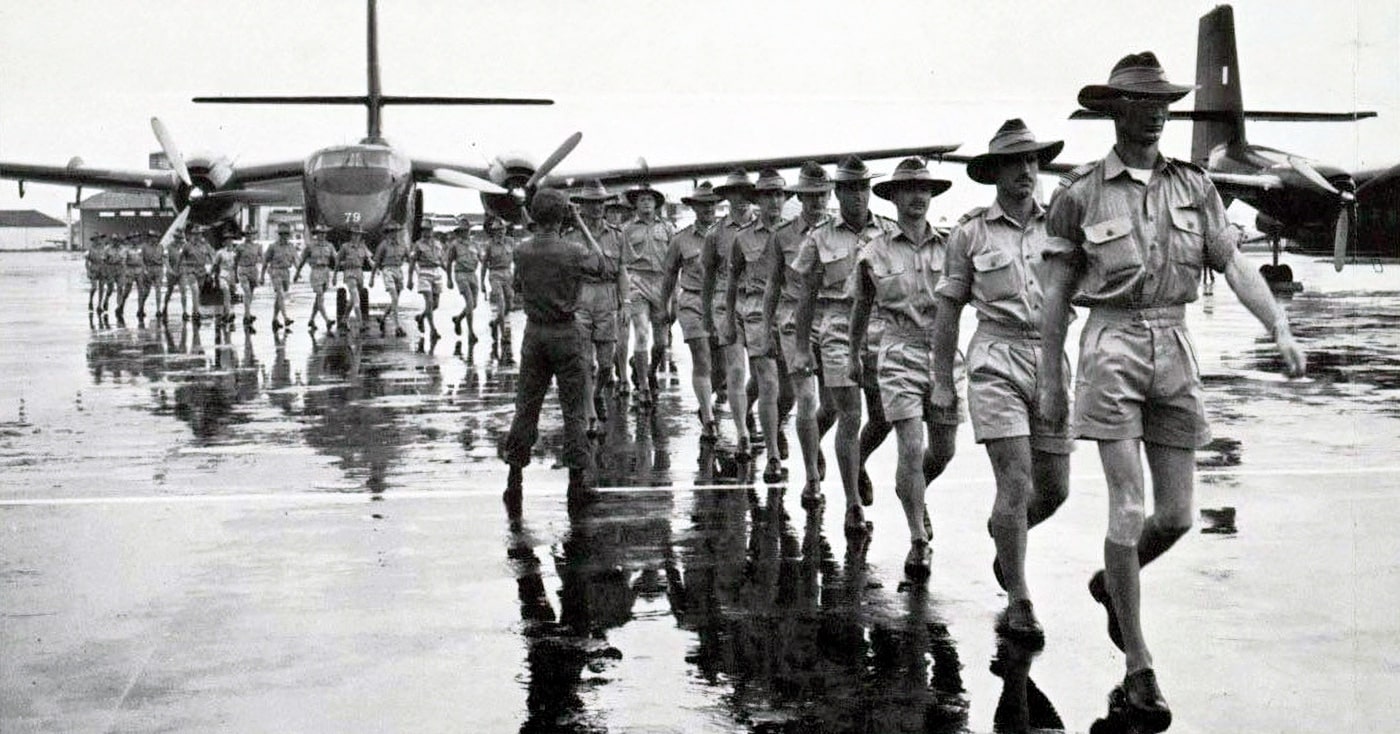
[0,0,958,249]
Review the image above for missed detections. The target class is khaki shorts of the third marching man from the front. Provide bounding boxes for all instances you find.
[876,332,967,426]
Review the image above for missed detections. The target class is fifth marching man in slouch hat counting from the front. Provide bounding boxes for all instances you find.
[763,161,832,507]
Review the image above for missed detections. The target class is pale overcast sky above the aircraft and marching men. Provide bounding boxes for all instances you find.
[0,0,1400,224]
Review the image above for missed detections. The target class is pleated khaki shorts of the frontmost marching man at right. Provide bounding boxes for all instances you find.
[1074,305,1211,448]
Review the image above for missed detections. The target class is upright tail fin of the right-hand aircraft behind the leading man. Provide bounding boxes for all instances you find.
[1191,6,1245,165]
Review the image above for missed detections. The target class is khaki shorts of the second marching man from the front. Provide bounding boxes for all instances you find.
[967,321,1074,454]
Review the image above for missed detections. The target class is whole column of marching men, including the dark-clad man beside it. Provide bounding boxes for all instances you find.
[79,52,1306,731]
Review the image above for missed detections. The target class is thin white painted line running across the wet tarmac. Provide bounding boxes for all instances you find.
[0,466,1400,507]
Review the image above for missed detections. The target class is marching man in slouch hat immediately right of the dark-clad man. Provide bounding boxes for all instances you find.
[564,179,631,437]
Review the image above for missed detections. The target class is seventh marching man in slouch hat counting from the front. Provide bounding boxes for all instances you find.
[700,171,753,459]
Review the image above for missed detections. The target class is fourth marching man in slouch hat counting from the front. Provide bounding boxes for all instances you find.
[784,157,897,529]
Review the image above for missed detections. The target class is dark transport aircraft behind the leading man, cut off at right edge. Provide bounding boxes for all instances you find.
[1074,6,1400,282]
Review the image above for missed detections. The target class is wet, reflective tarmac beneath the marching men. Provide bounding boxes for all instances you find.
[0,254,1400,733]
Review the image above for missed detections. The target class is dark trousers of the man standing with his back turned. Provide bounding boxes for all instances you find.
[501,321,591,469]
